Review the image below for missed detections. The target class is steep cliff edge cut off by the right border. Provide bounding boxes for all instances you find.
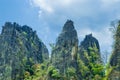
[108,22,120,80]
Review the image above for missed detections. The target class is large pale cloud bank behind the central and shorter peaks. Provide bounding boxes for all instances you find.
[30,0,120,53]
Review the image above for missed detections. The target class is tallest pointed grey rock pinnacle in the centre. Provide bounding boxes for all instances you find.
[51,20,78,74]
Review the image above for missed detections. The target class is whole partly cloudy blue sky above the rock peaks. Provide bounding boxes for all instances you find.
[0,0,120,52]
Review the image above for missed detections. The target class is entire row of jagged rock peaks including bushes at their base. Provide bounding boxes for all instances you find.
[0,20,120,80]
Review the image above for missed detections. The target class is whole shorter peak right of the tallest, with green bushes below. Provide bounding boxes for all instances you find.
[78,34,104,80]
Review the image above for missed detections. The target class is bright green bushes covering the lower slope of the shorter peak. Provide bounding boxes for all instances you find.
[78,46,105,80]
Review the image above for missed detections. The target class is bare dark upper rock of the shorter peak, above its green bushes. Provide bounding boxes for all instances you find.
[79,34,102,65]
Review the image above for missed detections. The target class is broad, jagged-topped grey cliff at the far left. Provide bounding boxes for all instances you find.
[0,22,49,80]
